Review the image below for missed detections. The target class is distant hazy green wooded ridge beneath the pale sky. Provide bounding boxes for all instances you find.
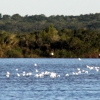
[0,13,100,33]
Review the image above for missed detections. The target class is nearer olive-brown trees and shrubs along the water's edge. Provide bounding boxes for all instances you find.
[0,25,100,58]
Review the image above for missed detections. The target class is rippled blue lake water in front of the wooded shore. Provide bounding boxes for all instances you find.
[0,58,100,100]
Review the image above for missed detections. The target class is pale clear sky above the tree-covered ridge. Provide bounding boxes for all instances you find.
[0,0,100,16]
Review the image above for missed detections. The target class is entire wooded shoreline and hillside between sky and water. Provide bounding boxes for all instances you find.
[0,14,100,58]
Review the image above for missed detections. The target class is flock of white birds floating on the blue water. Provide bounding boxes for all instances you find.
[6,59,100,78]
